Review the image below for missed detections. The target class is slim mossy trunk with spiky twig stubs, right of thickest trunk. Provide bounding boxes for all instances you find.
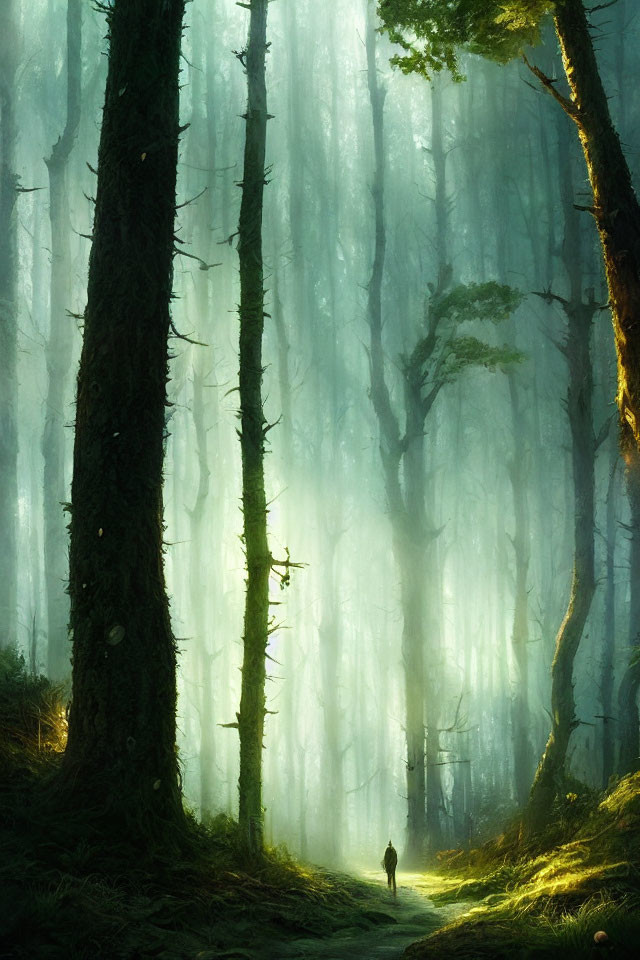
[238,0,272,854]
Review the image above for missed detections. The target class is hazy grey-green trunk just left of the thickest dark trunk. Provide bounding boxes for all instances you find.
[42,0,82,681]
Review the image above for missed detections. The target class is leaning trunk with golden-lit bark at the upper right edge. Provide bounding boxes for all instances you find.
[541,0,640,454]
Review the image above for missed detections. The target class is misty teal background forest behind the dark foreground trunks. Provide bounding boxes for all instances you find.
[5,0,640,863]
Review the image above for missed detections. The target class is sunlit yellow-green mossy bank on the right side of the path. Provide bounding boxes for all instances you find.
[406,773,640,960]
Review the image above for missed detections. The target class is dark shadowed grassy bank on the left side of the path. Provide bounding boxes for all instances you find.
[0,650,393,960]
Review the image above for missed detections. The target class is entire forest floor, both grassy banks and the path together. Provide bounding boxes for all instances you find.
[0,651,640,960]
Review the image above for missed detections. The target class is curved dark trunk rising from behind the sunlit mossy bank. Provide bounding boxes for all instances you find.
[527,117,599,830]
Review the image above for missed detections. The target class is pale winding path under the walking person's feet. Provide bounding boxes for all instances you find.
[270,871,466,960]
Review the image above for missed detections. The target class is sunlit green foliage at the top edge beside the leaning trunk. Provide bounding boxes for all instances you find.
[379,0,554,80]
